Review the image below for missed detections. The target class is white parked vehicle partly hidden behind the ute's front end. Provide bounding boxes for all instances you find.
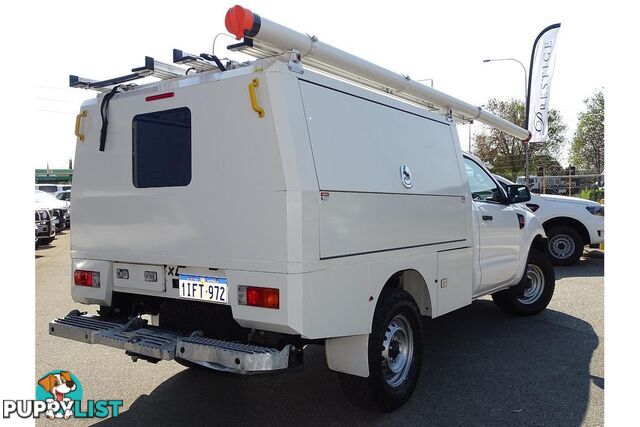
[494,175,604,265]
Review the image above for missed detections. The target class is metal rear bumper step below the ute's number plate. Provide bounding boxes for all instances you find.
[49,310,291,373]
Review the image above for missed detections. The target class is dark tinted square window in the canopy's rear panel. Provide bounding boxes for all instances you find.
[133,107,191,188]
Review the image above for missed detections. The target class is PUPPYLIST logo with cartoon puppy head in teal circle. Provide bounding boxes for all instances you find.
[2,370,122,420]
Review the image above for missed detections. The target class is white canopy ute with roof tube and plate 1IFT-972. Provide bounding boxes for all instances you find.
[49,6,555,411]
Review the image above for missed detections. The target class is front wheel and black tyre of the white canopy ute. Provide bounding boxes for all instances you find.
[491,249,556,316]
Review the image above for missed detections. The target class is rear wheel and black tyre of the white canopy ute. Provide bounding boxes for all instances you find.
[340,289,422,412]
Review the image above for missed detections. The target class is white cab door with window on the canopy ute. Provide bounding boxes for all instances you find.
[464,157,521,290]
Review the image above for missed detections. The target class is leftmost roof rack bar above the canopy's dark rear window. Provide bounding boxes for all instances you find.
[69,56,186,92]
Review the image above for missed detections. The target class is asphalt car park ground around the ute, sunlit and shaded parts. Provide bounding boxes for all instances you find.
[34,231,604,425]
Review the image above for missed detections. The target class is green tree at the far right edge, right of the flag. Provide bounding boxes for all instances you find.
[571,89,604,173]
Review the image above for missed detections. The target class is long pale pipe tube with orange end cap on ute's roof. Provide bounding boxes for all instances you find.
[225,6,531,141]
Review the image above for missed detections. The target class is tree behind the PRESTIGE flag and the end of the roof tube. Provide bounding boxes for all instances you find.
[473,99,567,180]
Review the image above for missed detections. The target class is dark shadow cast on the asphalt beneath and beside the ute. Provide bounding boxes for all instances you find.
[101,300,604,425]
